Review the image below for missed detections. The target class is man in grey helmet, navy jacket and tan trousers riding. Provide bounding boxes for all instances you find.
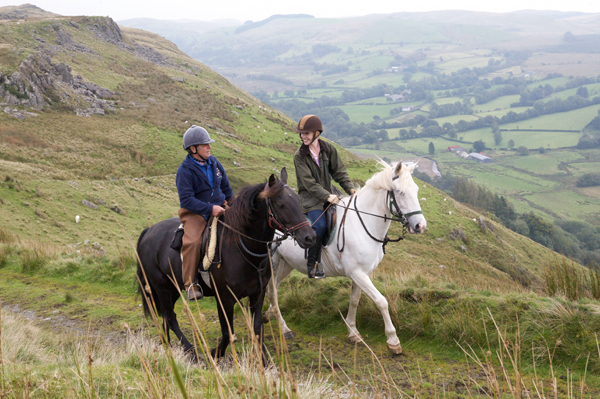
[176,125,234,300]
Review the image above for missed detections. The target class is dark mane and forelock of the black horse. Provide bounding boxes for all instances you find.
[223,180,285,231]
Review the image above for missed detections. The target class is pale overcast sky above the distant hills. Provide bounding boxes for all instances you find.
[0,0,600,21]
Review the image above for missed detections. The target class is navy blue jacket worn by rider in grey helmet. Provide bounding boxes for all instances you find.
[175,155,233,219]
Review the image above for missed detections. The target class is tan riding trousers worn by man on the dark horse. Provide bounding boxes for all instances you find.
[179,208,206,290]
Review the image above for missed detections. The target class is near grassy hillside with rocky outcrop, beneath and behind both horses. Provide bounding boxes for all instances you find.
[0,5,600,397]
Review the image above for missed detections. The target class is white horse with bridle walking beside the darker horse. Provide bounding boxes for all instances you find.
[263,161,427,354]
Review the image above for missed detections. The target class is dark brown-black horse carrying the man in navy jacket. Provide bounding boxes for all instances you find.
[137,168,316,360]
